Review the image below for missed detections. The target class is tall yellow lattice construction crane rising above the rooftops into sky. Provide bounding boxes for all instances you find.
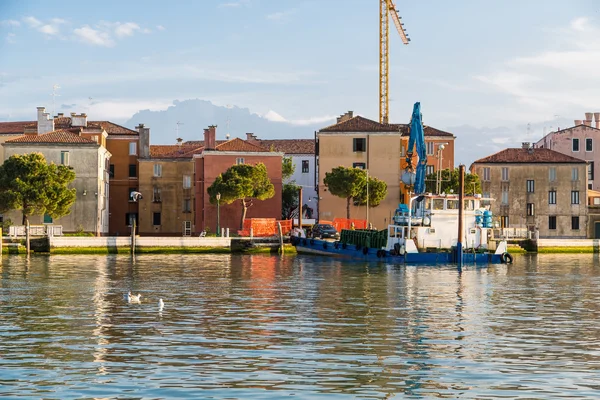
[379,0,410,124]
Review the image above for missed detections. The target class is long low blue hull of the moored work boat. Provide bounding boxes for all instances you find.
[293,239,504,265]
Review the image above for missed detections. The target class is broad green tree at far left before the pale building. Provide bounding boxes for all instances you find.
[0,153,75,225]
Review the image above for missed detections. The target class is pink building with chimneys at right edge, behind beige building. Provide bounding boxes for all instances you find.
[534,113,600,191]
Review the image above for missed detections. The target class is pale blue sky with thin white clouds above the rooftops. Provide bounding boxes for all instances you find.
[0,0,600,135]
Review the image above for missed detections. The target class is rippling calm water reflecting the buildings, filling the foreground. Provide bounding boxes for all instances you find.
[0,255,600,399]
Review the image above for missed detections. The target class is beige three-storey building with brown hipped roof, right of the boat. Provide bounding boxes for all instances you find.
[471,143,588,238]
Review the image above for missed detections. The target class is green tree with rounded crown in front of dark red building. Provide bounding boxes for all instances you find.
[206,163,275,229]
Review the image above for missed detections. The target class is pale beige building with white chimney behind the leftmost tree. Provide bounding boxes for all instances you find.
[2,107,111,235]
